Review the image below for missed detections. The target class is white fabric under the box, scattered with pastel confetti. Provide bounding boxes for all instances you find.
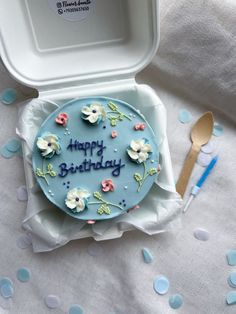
[0,0,236,314]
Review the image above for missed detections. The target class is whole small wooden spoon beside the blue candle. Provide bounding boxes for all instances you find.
[176,112,214,197]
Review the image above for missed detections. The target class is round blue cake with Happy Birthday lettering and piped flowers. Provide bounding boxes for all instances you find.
[32,97,159,223]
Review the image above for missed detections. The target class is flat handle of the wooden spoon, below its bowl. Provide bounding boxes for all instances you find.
[176,144,201,198]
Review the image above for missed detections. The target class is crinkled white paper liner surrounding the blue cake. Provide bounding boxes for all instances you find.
[16,99,182,252]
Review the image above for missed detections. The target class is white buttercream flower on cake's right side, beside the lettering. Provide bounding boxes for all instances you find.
[127,138,152,163]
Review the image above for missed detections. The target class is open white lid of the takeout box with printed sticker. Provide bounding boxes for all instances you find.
[0,0,159,90]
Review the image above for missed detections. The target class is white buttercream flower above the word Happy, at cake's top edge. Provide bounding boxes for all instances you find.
[81,103,106,124]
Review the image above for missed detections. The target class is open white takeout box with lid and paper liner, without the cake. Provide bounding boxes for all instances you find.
[0,0,180,251]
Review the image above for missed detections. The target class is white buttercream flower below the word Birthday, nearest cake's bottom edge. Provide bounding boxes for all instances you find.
[65,188,90,213]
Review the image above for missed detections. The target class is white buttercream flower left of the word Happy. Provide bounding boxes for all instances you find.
[36,133,61,158]
